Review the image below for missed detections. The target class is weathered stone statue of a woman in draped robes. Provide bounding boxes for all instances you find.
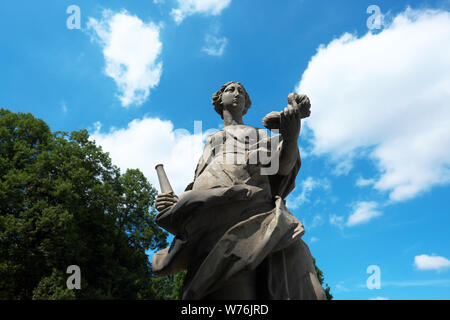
[152,82,326,300]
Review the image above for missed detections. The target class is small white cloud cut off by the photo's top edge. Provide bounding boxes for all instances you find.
[171,0,231,24]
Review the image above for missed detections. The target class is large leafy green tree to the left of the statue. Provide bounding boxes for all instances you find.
[0,109,167,299]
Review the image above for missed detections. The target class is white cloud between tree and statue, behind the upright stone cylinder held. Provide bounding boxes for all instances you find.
[91,117,207,194]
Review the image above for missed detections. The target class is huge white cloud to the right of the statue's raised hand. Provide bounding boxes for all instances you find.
[296,8,450,201]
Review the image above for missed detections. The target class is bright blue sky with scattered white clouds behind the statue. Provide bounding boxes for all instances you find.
[0,0,450,300]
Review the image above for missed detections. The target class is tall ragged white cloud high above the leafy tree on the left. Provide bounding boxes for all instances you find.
[87,10,162,107]
